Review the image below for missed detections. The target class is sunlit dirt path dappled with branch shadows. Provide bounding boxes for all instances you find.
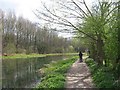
[65,60,94,89]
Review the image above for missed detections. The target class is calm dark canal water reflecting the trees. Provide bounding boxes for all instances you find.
[2,56,69,88]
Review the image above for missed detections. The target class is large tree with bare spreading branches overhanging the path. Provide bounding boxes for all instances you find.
[35,0,117,65]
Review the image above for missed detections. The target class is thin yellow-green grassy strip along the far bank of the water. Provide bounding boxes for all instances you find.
[0,53,77,59]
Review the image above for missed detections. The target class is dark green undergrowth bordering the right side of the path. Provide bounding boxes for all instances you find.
[86,58,120,89]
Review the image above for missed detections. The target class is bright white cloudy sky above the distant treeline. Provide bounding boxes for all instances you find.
[0,0,93,37]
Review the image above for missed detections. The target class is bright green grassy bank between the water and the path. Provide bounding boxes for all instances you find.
[36,57,78,89]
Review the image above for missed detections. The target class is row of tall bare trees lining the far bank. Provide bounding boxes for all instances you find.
[0,10,74,54]
